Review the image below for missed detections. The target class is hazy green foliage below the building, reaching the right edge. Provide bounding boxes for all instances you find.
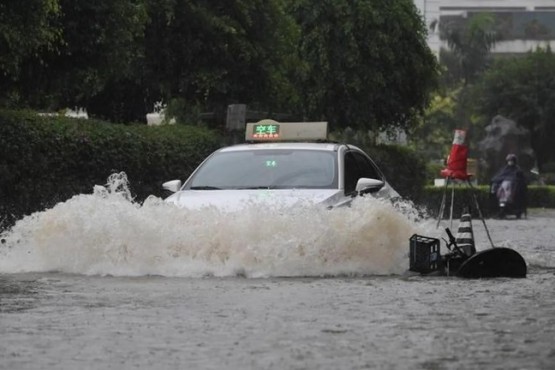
[410,14,555,184]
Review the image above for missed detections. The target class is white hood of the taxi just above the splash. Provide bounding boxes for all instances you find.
[166,189,351,211]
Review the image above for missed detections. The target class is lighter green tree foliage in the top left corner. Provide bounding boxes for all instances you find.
[0,0,61,105]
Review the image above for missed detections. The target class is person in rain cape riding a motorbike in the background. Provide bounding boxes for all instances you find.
[491,154,526,218]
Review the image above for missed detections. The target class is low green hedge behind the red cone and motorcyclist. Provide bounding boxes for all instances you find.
[419,185,555,217]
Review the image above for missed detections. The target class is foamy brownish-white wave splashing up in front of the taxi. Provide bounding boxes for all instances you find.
[0,176,431,277]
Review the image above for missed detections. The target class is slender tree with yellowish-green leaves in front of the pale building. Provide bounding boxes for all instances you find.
[411,14,500,166]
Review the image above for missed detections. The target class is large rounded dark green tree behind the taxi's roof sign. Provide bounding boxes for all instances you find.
[291,0,437,130]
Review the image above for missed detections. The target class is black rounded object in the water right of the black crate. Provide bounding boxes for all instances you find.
[457,248,526,279]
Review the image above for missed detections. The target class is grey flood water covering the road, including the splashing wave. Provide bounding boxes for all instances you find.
[0,178,555,370]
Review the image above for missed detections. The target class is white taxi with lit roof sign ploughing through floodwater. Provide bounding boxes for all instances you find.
[163,120,399,210]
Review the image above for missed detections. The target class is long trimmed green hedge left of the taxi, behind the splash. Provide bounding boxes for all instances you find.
[0,107,221,229]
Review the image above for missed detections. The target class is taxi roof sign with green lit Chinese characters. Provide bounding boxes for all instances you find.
[245,119,328,142]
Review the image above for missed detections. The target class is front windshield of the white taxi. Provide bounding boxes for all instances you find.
[185,149,337,190]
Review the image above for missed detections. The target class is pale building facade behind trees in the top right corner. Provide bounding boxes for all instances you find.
[414,0,555,56]
